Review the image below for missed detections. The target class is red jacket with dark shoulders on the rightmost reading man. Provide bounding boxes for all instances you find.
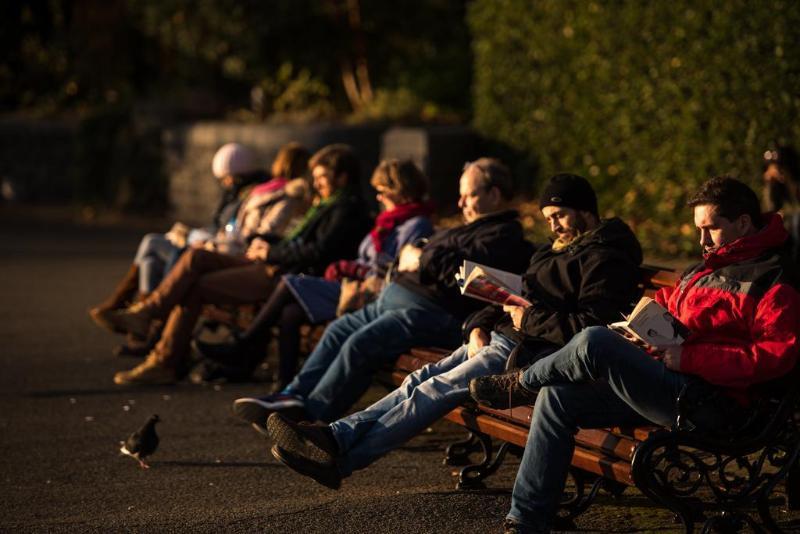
[656,214,800,396]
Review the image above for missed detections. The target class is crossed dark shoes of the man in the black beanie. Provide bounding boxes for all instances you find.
[267,413,342,489]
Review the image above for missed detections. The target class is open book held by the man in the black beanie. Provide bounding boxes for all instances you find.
[456,260,531,306]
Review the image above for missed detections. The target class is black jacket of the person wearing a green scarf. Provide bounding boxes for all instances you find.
[267,192,372,276]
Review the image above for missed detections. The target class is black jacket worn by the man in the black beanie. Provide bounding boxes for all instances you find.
[464,218,642,352]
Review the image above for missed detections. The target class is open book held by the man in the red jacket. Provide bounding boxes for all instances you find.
[608,297,689,347]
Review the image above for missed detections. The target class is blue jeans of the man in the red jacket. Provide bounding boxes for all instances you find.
[507,326,690,532]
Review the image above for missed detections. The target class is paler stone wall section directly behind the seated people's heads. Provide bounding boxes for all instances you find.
[164,122,477,224]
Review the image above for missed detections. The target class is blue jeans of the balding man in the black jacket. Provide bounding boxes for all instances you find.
[286,284,461,421]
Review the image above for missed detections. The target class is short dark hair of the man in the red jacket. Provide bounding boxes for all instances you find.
[686,176,761,228]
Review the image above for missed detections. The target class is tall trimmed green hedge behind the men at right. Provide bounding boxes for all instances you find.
[468,0,800,256]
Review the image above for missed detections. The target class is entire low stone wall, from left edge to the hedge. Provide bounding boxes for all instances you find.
[0,116,479,225]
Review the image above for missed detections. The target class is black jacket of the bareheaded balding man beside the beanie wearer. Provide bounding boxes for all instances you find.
[395,210,533,319]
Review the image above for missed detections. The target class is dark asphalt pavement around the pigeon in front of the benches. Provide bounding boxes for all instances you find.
[0,211,780,534]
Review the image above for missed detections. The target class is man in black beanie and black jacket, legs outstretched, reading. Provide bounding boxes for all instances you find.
[267,174,642,494]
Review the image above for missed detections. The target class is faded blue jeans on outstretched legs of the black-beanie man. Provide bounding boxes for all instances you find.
[331,332,515,476]
